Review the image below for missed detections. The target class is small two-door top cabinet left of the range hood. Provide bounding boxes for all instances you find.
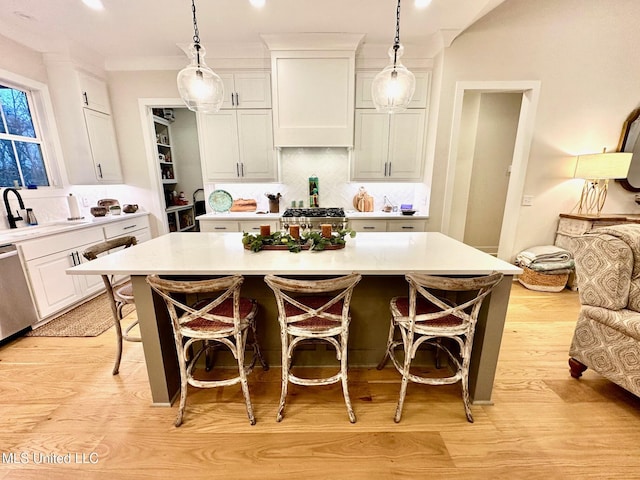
[220,72,271,109]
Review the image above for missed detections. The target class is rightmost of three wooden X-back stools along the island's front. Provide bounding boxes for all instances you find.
[378,273,503,423]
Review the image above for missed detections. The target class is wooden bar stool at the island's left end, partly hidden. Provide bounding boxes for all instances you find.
[82,236,141,375]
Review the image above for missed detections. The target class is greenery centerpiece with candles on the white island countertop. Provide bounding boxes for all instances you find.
[242,228,356,253]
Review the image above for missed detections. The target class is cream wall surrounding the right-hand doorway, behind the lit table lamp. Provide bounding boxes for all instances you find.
[429,0,640,254]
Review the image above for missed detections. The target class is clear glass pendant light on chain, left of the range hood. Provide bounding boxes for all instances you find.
[178,0,224,113]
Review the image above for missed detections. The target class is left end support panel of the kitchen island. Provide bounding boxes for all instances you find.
[131,275,180,406]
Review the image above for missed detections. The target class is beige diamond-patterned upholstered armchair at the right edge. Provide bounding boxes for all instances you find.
[569,224,640,396]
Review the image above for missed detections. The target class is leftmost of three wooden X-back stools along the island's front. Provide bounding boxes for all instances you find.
[147,275,269,427]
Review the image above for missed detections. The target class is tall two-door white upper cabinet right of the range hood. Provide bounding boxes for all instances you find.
[351,109,426,181]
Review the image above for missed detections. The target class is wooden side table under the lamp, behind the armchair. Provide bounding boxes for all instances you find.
[554,213,640,290]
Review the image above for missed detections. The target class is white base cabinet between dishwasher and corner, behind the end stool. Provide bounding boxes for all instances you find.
[20,227,104,319]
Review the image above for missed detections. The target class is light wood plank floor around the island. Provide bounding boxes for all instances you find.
[0,284,640,480]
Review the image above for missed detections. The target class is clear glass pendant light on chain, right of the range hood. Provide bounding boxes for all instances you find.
[371,0,416,113]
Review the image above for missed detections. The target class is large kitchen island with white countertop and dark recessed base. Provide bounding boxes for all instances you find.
[67,232,521,405]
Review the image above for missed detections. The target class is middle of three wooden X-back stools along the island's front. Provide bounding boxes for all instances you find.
[264,273,362,423]
